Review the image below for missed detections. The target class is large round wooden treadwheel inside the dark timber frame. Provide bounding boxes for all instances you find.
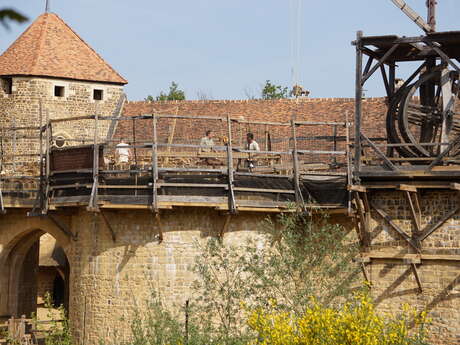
[387,66,460,158]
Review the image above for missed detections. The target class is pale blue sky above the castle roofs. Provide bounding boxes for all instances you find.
[0,0,460,100]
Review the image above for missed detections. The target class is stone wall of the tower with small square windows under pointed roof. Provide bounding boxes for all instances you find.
[0,77,123,175]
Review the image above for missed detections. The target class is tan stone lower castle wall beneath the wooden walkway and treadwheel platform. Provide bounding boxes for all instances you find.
[0,191,460,345]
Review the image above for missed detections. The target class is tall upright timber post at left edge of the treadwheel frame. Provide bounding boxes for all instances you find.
[354,31,363,173]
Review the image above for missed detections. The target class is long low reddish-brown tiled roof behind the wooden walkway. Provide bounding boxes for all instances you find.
[115,98,387,141]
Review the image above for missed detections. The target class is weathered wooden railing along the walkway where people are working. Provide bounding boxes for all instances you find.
[0,114,351,213]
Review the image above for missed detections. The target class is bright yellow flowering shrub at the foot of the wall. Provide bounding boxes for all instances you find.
[248,295,428,345]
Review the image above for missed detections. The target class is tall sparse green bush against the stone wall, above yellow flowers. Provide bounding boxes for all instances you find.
[190,213,359,337]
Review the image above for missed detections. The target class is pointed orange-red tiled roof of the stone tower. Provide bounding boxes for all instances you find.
[0,13,128,84]
